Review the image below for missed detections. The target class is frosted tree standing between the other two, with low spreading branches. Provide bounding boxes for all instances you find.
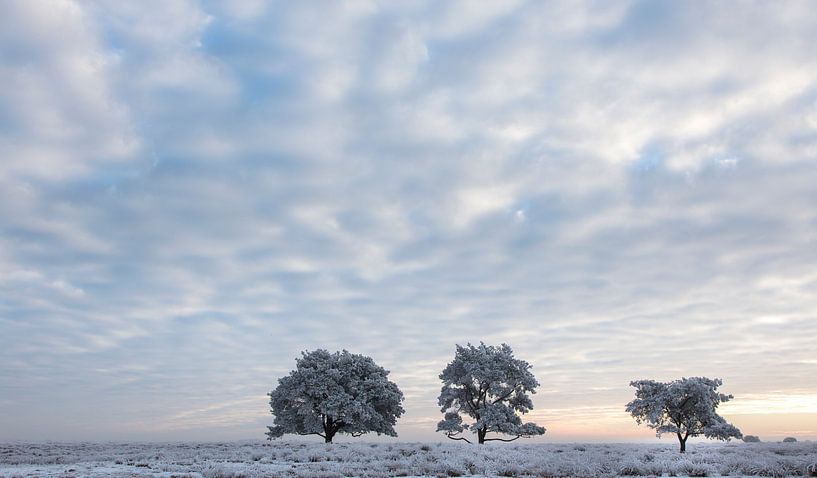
[437,343,545,444]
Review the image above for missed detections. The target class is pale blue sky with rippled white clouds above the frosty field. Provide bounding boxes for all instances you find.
[0,0,817,443]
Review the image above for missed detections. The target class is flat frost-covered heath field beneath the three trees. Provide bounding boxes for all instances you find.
[0,442,817,478]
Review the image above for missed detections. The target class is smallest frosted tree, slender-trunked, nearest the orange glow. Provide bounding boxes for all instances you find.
[627,377,743,453]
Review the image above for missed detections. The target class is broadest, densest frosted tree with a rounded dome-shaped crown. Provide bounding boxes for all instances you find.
[267,349,404,443]
